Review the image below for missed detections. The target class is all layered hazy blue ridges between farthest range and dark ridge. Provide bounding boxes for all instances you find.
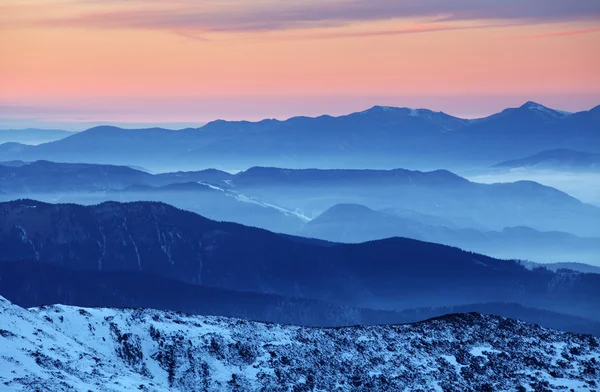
[0,161,600,264]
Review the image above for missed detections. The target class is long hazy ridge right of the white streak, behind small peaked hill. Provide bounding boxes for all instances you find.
[227,167,600,237]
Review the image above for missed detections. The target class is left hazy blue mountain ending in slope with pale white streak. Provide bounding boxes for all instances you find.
[0,161,303,233]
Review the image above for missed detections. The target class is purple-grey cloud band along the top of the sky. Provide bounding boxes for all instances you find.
[8,0,600,34]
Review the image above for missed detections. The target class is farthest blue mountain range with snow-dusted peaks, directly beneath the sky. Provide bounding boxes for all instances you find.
[0,102,600,171]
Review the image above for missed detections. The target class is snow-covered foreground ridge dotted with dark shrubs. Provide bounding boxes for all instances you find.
[0,297,600,391]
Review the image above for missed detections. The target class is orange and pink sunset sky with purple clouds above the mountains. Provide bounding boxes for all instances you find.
[0,0,600,130]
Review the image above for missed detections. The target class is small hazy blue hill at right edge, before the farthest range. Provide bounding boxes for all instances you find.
[492,149,600,171]
